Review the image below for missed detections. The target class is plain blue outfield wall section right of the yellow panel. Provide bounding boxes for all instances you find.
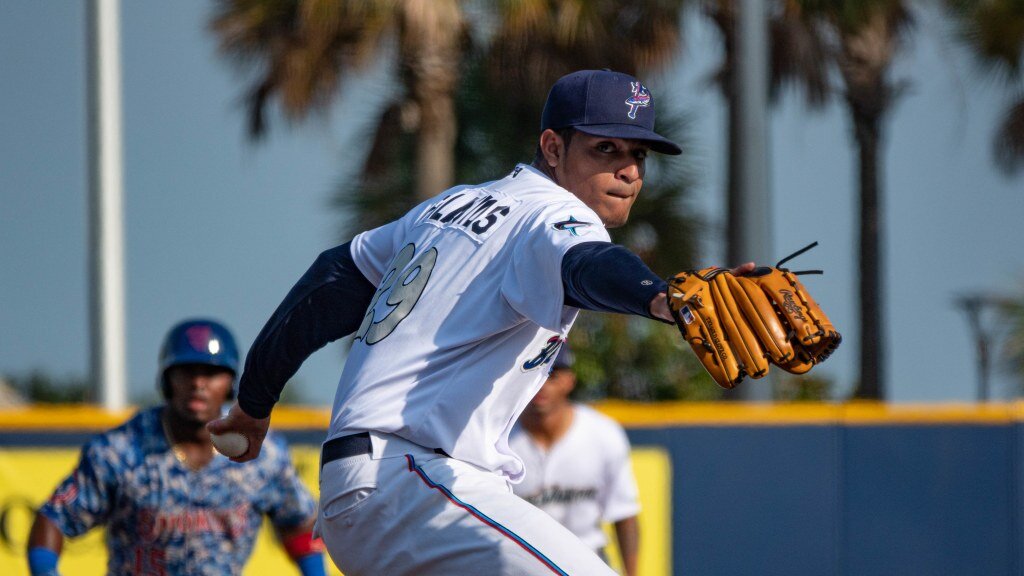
[628,422,1024,576]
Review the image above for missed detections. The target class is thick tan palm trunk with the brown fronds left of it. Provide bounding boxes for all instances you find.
[211,0,466,198]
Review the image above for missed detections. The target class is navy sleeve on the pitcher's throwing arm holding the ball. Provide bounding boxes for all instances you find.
[239,243,376,418]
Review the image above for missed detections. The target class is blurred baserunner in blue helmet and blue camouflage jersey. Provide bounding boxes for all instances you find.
[29,320,325,576]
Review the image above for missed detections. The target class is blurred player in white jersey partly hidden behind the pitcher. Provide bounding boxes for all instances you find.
[509,345,640,576]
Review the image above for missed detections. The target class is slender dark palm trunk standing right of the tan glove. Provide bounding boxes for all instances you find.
[850,98,886,400]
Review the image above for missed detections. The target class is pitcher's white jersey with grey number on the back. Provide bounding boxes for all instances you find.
[329,164,609,482]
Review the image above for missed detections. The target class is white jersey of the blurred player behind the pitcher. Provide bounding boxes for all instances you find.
[509,404,640,549]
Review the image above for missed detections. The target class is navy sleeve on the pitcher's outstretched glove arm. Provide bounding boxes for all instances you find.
[562,242,668,320]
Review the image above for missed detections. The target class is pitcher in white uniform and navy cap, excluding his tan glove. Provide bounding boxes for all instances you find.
[209,71,679,576]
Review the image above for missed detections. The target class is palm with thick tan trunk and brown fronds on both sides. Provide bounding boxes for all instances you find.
[211,0,696,203]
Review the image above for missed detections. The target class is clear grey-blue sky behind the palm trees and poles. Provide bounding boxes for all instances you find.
[0,0,1024,403]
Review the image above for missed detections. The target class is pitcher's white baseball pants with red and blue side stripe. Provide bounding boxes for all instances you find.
[317,436,615,576]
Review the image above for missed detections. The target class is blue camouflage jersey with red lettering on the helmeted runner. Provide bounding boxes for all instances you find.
[40,407,315,576]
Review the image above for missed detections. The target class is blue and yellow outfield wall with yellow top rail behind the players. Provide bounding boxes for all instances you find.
[0,403,1024,576]
